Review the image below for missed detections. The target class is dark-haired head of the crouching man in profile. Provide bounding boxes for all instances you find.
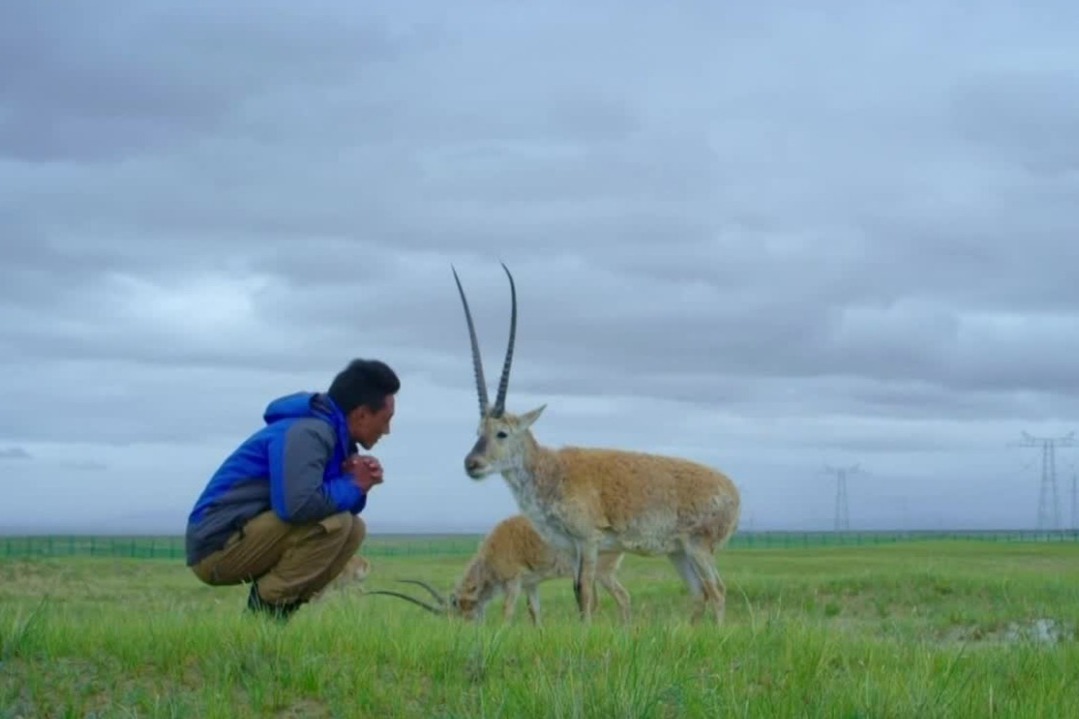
[327,360,401,449]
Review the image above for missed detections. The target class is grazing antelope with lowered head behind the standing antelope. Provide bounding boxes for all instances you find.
[367,514,630,625]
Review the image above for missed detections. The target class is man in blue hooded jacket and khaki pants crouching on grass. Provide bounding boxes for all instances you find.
[187,360,400,620]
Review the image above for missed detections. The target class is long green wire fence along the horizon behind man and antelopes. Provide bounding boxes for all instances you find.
[0,530,1079,560]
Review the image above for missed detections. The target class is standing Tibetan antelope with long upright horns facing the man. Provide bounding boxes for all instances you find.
[453,263,741,622]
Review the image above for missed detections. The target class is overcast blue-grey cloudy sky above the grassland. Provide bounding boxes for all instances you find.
[0,0,1079,533]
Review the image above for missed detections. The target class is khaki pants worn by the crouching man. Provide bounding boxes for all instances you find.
[191,511,367,605]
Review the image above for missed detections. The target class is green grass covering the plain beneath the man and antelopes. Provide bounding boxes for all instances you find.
[0,541,1079,719]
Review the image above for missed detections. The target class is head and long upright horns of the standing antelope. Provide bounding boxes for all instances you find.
[453,263,546,479]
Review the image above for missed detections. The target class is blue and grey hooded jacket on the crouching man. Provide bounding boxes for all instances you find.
[186,392,367,567]
